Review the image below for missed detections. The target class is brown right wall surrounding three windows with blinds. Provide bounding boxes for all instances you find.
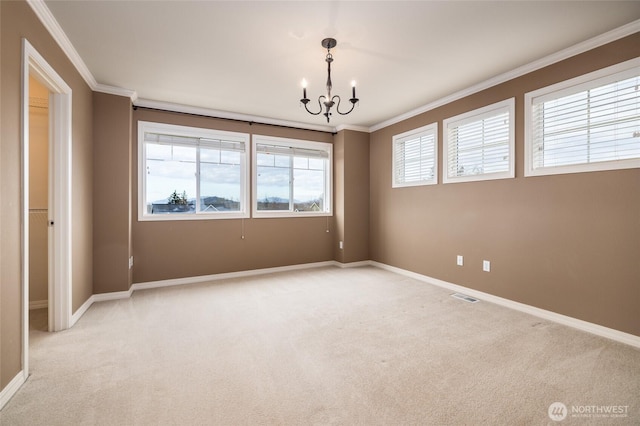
[370,34,640,336]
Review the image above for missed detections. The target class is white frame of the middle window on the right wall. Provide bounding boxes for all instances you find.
[442,98,515,183]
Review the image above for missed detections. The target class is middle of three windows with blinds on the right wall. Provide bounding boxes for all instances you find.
[442,98,515,183]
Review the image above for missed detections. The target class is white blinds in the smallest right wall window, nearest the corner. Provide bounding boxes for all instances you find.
[394,130,437,185]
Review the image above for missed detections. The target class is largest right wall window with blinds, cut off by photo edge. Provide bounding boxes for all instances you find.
[525,59,640,176]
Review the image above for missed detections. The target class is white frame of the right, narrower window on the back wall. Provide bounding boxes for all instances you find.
[251,135,333,218]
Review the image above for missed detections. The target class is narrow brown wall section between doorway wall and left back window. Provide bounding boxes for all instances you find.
[93,93,132,294]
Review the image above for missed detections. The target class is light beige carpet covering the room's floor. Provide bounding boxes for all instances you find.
[0,267,640,425]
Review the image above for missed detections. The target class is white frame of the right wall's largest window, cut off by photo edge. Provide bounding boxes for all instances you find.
[524,58,640,176]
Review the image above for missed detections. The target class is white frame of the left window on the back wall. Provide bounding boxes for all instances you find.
[138,121,250,221]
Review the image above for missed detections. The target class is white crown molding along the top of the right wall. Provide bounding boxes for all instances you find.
[369,19,640,133]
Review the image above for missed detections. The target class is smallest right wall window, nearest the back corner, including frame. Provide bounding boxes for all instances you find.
[392,123,438,188]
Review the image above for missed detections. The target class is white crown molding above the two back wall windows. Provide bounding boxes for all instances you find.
[134,99,336,133]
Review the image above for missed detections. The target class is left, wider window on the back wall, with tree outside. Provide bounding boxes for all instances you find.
[138,121,249,220]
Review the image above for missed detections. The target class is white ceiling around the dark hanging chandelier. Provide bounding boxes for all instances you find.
[45,1,640,128]
